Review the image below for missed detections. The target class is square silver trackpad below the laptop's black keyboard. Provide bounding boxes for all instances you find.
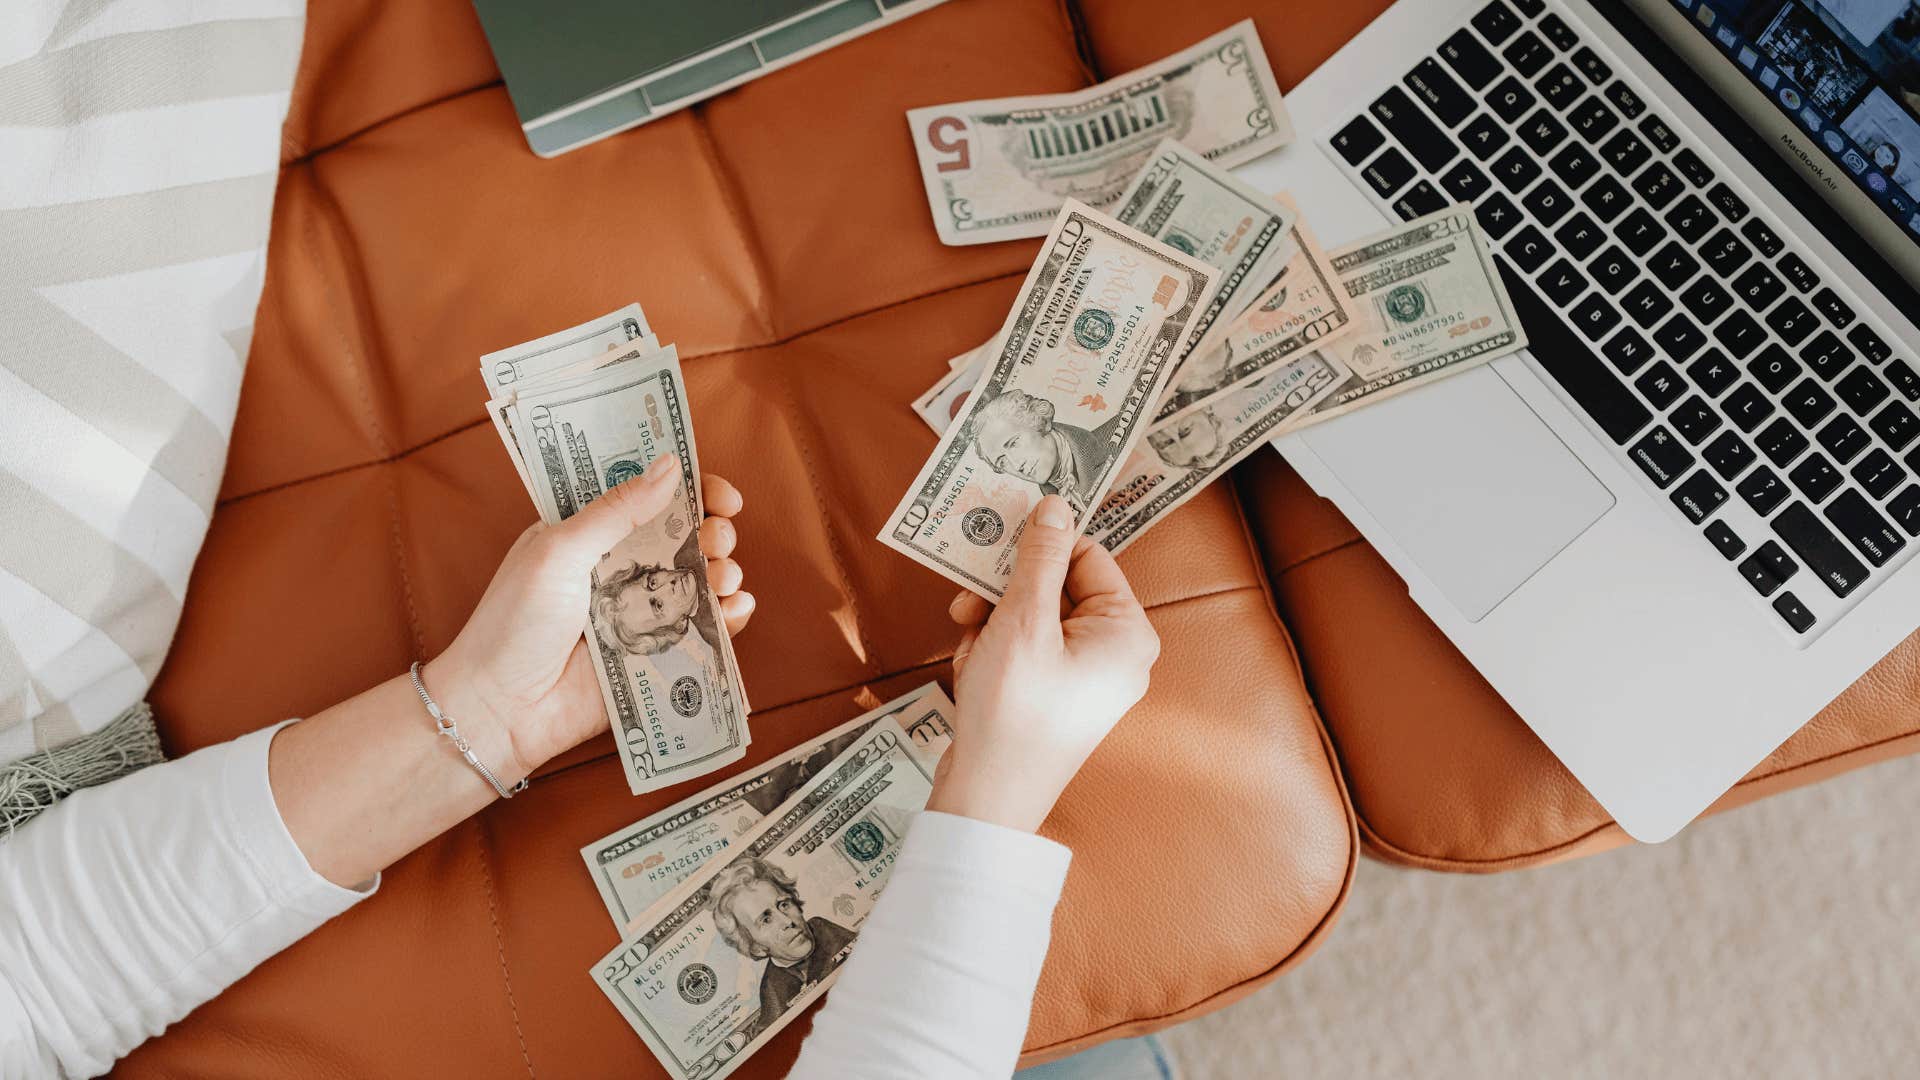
[1302,367,1613,623]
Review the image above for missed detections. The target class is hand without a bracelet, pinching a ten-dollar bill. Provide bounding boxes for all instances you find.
[927,496,1160,832]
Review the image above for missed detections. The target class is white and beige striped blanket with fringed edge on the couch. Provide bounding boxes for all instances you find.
[0,0,305,836]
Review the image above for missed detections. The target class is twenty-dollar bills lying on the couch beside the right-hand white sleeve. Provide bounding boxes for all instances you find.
[580,682,954,1080]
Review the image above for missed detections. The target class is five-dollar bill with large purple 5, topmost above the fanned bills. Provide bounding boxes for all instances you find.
[906,19,1294,244]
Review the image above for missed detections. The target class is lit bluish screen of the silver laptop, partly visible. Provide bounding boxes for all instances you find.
[1667,0,1920,270]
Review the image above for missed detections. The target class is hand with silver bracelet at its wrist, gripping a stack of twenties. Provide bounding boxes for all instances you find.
[420,455,755,772]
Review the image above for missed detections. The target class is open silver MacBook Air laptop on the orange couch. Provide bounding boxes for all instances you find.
[1238,0,1920,842]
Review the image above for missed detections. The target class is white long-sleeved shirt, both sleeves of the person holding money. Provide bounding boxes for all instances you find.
[0,728,1069,1080]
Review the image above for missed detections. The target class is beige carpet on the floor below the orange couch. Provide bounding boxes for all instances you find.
[1162,759,1920,1080]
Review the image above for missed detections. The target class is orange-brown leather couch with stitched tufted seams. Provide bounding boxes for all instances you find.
[119,0,1920,1078]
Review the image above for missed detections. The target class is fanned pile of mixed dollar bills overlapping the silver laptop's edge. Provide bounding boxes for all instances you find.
[894,21,1526,588]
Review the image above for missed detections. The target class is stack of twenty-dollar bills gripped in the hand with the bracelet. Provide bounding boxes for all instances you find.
[480,304,753,796]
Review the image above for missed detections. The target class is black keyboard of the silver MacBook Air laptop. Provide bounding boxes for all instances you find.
[1329,0,1920,640]
